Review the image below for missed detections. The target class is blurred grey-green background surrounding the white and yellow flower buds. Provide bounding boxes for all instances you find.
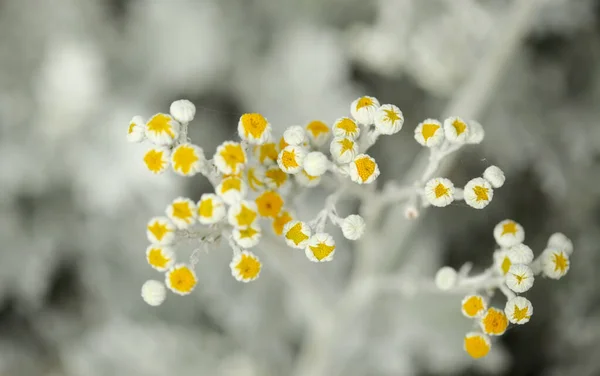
[0,0,600,376]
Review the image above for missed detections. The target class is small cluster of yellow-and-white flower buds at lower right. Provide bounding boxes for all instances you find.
[436,219,573,358]
